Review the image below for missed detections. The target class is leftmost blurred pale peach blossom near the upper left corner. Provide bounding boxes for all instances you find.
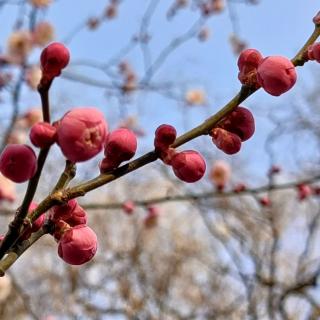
[7,30,32,62]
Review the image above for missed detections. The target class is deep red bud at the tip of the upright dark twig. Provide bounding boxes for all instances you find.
[40,42,70,79]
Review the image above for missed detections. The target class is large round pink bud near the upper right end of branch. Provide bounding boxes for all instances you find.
[257,56,297,96]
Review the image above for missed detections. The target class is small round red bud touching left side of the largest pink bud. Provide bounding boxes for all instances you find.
[30,122,57,148]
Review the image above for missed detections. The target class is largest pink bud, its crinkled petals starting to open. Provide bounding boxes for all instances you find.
[57,108,108,162]
